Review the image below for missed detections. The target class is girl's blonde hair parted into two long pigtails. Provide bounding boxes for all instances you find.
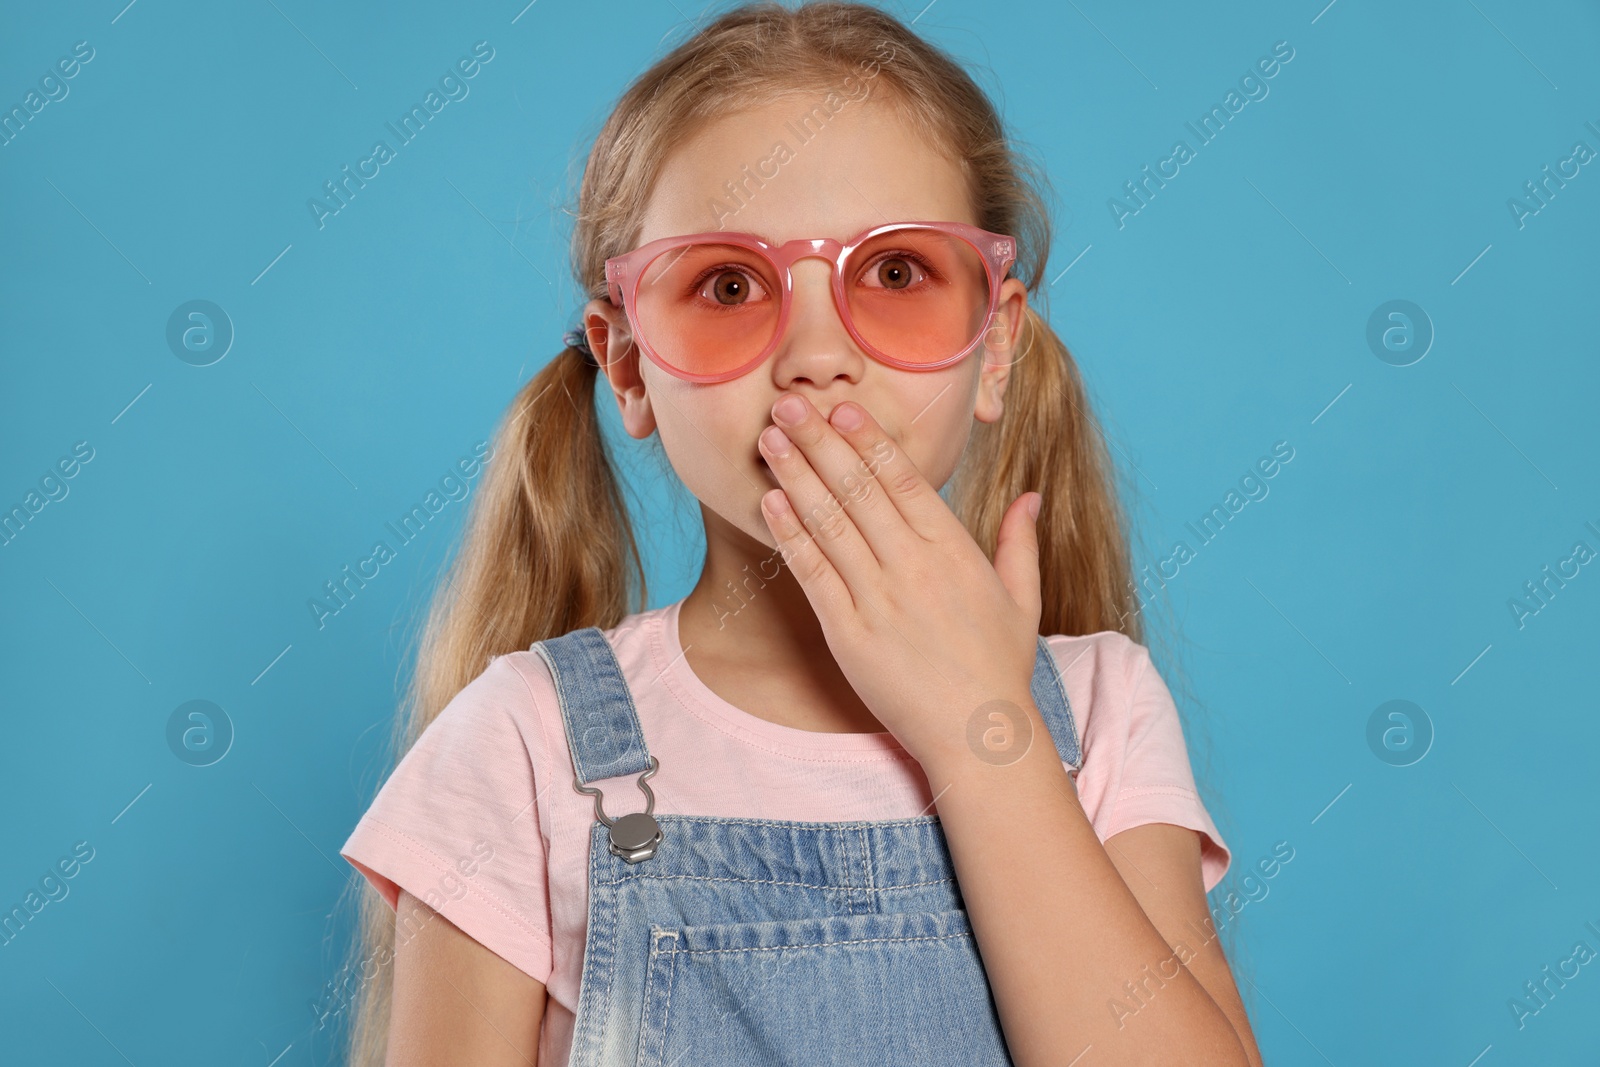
[334,3,1164,1067]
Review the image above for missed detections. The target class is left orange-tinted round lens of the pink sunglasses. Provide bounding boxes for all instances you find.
[634,243,782,376]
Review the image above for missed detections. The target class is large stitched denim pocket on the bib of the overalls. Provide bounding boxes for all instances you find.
[637,909,1011,1067]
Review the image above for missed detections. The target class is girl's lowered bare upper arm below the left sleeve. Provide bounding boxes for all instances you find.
[386,889,546,1067]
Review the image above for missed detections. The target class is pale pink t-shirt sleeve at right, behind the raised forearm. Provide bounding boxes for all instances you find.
[1054,632,1232,893]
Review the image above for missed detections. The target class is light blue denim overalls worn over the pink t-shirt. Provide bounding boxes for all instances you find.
[533,627,1082,1067]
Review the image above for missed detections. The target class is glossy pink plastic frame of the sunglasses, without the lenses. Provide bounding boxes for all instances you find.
[605,222,1016,384]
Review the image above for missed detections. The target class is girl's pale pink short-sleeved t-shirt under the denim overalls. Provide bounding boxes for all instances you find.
[339,600,1229,1067]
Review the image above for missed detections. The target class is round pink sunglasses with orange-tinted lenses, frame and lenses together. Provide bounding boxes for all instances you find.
[605,222,1016,382]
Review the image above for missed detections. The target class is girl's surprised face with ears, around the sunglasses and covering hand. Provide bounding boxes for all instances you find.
[586,94,1026,547]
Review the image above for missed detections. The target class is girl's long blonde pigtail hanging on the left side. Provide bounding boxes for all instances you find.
[339,347,646,1067]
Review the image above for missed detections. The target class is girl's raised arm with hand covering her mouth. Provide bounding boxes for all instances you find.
[748,394,1259,1067]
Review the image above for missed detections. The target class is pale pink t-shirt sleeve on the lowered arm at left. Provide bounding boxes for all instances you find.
[339,656,552,982]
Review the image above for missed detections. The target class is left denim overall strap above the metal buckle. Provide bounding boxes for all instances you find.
[533,625,650,785]
